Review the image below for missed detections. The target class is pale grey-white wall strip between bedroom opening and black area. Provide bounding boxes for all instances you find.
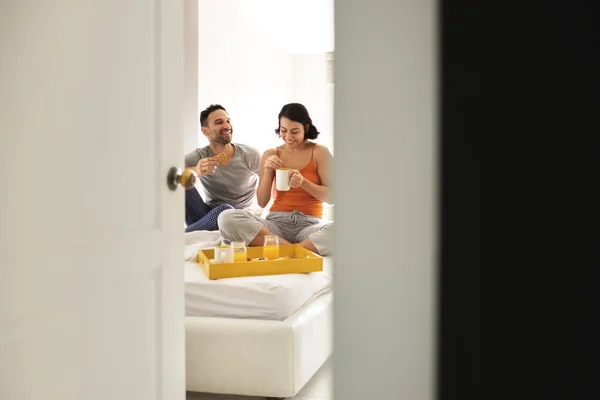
[334,0,437,400]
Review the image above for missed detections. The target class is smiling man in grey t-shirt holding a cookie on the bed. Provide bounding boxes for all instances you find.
[185,104,260,232]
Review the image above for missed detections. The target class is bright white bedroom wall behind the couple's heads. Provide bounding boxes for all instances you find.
[198,0,333,155]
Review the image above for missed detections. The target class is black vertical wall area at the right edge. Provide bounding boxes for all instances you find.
[438,0,600,400]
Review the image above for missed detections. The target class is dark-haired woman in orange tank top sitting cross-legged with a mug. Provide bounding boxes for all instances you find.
[218,103,333,256]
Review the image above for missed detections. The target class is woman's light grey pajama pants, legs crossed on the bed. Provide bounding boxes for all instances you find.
[218,210,333,256]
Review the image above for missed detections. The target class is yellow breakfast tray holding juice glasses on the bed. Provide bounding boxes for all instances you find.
[198,245,323,279]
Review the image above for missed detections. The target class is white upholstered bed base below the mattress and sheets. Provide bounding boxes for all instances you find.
[186,292,333,398]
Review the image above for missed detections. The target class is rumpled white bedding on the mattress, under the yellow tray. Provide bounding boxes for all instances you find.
[185,231,332,321]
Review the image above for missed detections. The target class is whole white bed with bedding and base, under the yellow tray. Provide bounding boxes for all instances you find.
[185,232,333,398]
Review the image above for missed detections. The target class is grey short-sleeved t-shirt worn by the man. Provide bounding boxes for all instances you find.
[185,143,260,209]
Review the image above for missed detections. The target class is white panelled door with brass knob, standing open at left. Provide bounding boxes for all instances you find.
[0,0,185,400]
